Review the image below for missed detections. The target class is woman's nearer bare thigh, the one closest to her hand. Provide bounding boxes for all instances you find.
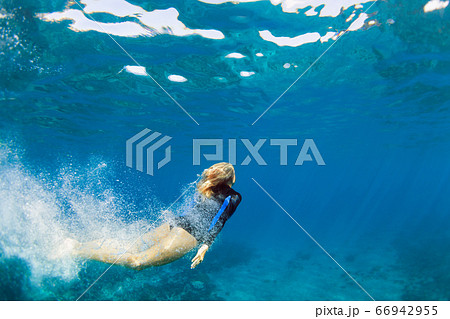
[127,227,197,270]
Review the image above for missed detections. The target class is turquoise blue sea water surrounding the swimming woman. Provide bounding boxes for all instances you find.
[0,0,450,300]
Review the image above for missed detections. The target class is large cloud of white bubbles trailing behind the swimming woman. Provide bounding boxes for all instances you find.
[0,146,159,282]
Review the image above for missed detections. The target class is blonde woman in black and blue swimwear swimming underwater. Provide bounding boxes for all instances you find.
[73,162,242,270]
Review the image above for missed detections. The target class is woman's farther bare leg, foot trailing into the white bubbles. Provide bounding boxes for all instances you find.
[74,223,170,266]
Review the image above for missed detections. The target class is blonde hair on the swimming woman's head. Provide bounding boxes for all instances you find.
[197,162,235,198]
